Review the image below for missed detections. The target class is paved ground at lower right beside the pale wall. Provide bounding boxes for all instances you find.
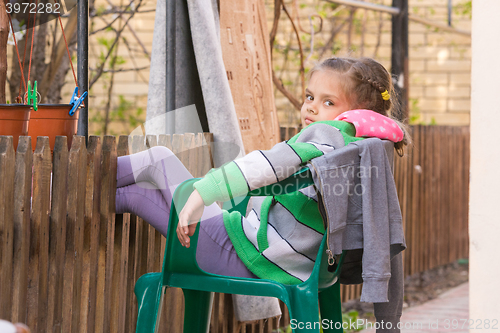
[361,282,469,333]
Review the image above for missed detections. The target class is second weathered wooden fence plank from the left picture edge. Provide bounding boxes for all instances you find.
[12,136,33,323]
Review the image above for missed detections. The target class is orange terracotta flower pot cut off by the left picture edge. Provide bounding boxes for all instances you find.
[0,104,31,150]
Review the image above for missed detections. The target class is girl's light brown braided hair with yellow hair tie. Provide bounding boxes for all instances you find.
[309,57,411,156]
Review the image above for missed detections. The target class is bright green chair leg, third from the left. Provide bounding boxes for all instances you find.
[288,289,321,333]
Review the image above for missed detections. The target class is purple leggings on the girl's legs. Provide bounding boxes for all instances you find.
[116,146,256,278]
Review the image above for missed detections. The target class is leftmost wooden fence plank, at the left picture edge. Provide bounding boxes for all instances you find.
[0,136,16,320]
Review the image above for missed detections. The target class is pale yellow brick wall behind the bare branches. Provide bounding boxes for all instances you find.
[5,0,471,134]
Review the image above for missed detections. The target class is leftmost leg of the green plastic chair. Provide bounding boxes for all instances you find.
[134,273,162,333]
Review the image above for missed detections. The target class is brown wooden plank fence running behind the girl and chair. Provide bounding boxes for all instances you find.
[0,126,469,333]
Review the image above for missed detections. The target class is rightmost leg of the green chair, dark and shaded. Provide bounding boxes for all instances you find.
[319,281,343,333]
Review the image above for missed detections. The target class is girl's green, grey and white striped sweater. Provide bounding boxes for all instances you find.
[194,121,362,284]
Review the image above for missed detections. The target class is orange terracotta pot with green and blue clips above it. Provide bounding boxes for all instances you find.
[28,104,79,150]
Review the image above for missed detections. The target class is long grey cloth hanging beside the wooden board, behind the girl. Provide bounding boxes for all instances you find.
[143,0,281,321]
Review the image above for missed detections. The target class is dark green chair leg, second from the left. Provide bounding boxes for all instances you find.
[182,289,214,333]
